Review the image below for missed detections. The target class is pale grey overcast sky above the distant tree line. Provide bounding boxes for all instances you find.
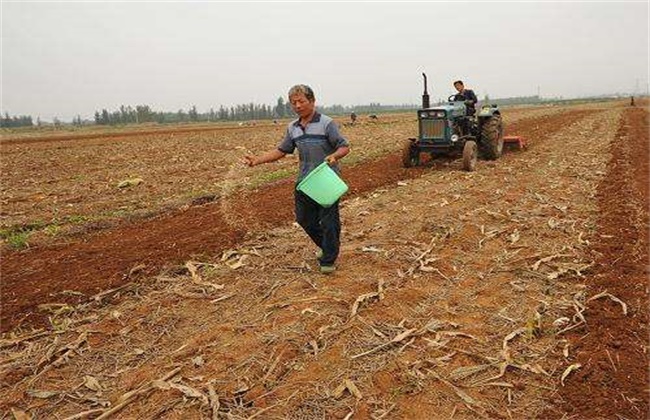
[1,0,649,121]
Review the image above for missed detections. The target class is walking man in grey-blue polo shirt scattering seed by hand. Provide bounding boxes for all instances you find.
[244,85,350,274]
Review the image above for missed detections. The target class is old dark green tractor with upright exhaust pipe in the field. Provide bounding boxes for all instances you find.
[402,73,504,171]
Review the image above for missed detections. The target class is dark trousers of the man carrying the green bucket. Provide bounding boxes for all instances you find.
[295,190,341,265]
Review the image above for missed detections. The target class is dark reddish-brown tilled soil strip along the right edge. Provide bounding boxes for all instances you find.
[548,108,650,419]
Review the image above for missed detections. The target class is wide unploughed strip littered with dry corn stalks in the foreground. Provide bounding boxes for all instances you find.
[3,100,647,418]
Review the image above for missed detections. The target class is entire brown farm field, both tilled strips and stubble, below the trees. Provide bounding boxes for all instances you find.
[0,101,650,419]
